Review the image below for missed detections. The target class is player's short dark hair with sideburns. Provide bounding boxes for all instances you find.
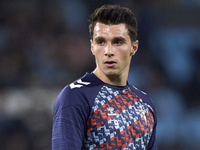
[88,4,138,42]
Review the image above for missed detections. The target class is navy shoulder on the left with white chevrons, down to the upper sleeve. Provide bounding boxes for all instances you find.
[54,73,102,114]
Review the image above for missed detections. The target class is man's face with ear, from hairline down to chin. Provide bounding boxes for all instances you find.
[91,22,138,76]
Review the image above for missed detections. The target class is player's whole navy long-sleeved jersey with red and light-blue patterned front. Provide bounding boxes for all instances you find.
[52,73,157,150]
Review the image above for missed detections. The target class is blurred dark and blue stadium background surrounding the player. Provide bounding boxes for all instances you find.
[0,0,200,150]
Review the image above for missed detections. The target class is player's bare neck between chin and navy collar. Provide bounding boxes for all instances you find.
[93,69,128,86]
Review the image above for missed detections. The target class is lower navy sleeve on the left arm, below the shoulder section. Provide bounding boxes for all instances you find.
[52,105,88,150]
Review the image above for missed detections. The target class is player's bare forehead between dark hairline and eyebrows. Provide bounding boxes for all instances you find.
[93,22,129,38]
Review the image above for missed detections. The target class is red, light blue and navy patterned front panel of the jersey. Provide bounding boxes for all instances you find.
[84,86,154,150]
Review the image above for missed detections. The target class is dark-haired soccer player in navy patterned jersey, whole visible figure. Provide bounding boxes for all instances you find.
[52,5,157,150]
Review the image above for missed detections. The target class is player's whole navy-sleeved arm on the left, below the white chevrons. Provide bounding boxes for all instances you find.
[52,86,90,150]
